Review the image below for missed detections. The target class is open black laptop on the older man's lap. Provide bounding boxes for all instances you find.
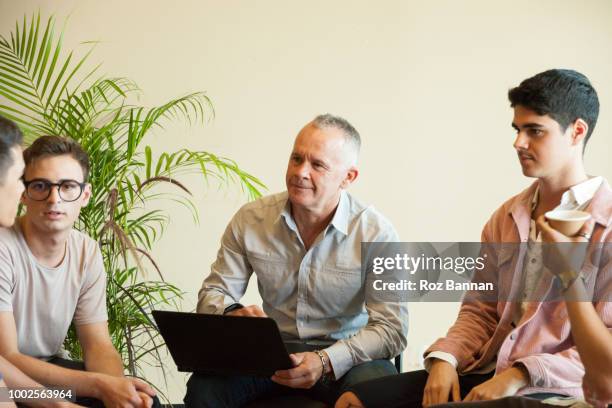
[153,310,293,377]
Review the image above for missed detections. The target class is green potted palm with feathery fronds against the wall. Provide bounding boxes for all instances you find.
[0,13,264,396]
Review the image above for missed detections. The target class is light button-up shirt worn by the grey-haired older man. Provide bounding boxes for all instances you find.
[197,191,408,378]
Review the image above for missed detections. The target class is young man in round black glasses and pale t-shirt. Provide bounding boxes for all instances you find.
[0,136,159,407]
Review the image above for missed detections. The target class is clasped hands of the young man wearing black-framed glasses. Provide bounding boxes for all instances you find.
[96,374,155,408]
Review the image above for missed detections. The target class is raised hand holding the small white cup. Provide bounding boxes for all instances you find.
[536,215,595,275]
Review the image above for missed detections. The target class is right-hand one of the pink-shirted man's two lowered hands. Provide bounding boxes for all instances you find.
[463,367,529,402]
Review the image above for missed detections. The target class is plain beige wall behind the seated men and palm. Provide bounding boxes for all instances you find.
[0,0,612,401]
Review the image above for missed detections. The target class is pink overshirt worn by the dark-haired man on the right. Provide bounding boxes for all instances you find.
[425,181,612,397]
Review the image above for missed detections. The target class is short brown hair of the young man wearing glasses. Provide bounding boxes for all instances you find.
[23,136,89,182]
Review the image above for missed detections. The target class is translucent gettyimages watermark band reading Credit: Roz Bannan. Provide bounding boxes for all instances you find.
[361,242,612,302]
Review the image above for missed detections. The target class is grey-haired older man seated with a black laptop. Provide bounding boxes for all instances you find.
[185,115,407,407]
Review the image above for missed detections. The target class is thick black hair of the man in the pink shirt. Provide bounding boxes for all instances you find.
[508,69,599,146]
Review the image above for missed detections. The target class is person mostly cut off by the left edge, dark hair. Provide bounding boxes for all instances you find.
[0,116,72,407]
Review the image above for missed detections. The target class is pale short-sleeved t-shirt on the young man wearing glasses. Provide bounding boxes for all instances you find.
[0,223,107,359]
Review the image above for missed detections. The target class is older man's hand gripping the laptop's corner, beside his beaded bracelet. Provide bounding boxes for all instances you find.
[272,351,323,389]
